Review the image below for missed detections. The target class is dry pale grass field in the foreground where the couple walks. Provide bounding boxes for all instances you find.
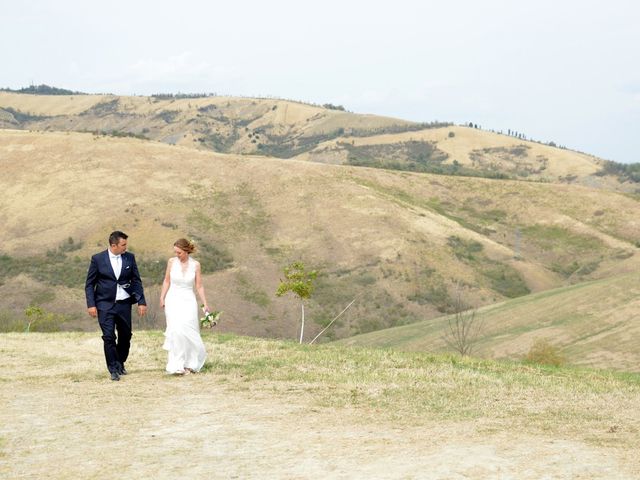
[0,332,640,480]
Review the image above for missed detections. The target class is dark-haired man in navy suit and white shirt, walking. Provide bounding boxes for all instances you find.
[85,231,147,380]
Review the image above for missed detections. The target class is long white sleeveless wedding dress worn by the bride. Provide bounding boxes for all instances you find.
[162,257,207,373]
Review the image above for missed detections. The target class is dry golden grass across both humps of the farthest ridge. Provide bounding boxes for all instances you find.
[0,92,616,191]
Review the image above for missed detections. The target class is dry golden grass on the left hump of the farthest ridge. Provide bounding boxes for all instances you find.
[0,88,412,153]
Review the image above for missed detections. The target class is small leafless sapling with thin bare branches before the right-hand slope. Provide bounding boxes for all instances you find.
[442,286,484,356]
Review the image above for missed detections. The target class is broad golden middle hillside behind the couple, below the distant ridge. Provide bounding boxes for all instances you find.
[0,130,640,344]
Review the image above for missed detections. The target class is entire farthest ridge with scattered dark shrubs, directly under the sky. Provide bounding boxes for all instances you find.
[0,92,638,192]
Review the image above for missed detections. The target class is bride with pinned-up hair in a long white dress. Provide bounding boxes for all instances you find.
[160,238,209,375]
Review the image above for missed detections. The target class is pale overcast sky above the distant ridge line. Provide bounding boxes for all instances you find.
[0,0,640,162]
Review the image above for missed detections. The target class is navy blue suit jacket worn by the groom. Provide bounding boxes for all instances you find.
[85,250,147,310]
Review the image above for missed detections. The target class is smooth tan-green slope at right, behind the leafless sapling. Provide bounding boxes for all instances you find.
[341,272,640,372]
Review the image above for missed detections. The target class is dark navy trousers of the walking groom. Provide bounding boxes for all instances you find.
[98,303,131,372]
